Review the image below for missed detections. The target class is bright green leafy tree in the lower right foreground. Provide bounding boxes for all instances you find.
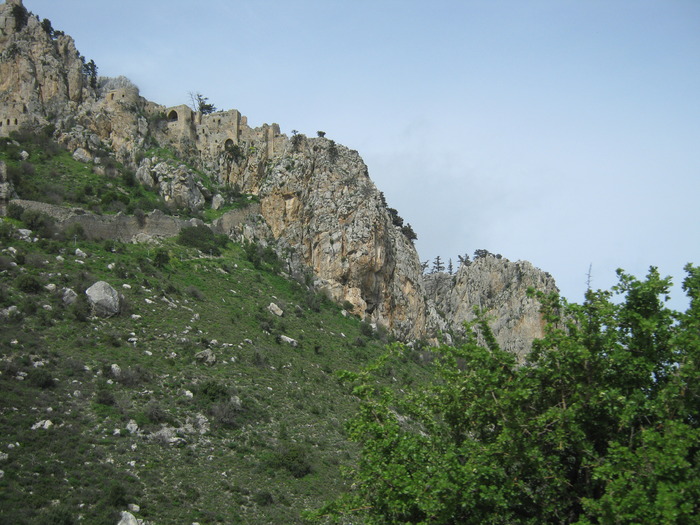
[320,265,700,524]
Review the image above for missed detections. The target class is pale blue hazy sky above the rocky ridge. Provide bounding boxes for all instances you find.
[24,0,700,309]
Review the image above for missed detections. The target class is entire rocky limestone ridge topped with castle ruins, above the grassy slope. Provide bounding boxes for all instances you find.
[0,0,553,352]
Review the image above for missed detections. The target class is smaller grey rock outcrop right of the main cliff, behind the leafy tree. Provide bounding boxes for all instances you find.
[424,255,558,359]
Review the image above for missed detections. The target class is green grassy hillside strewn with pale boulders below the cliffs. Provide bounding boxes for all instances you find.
[0,132,434,524]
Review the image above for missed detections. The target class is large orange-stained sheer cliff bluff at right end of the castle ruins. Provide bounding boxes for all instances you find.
[253,138,425,338]
